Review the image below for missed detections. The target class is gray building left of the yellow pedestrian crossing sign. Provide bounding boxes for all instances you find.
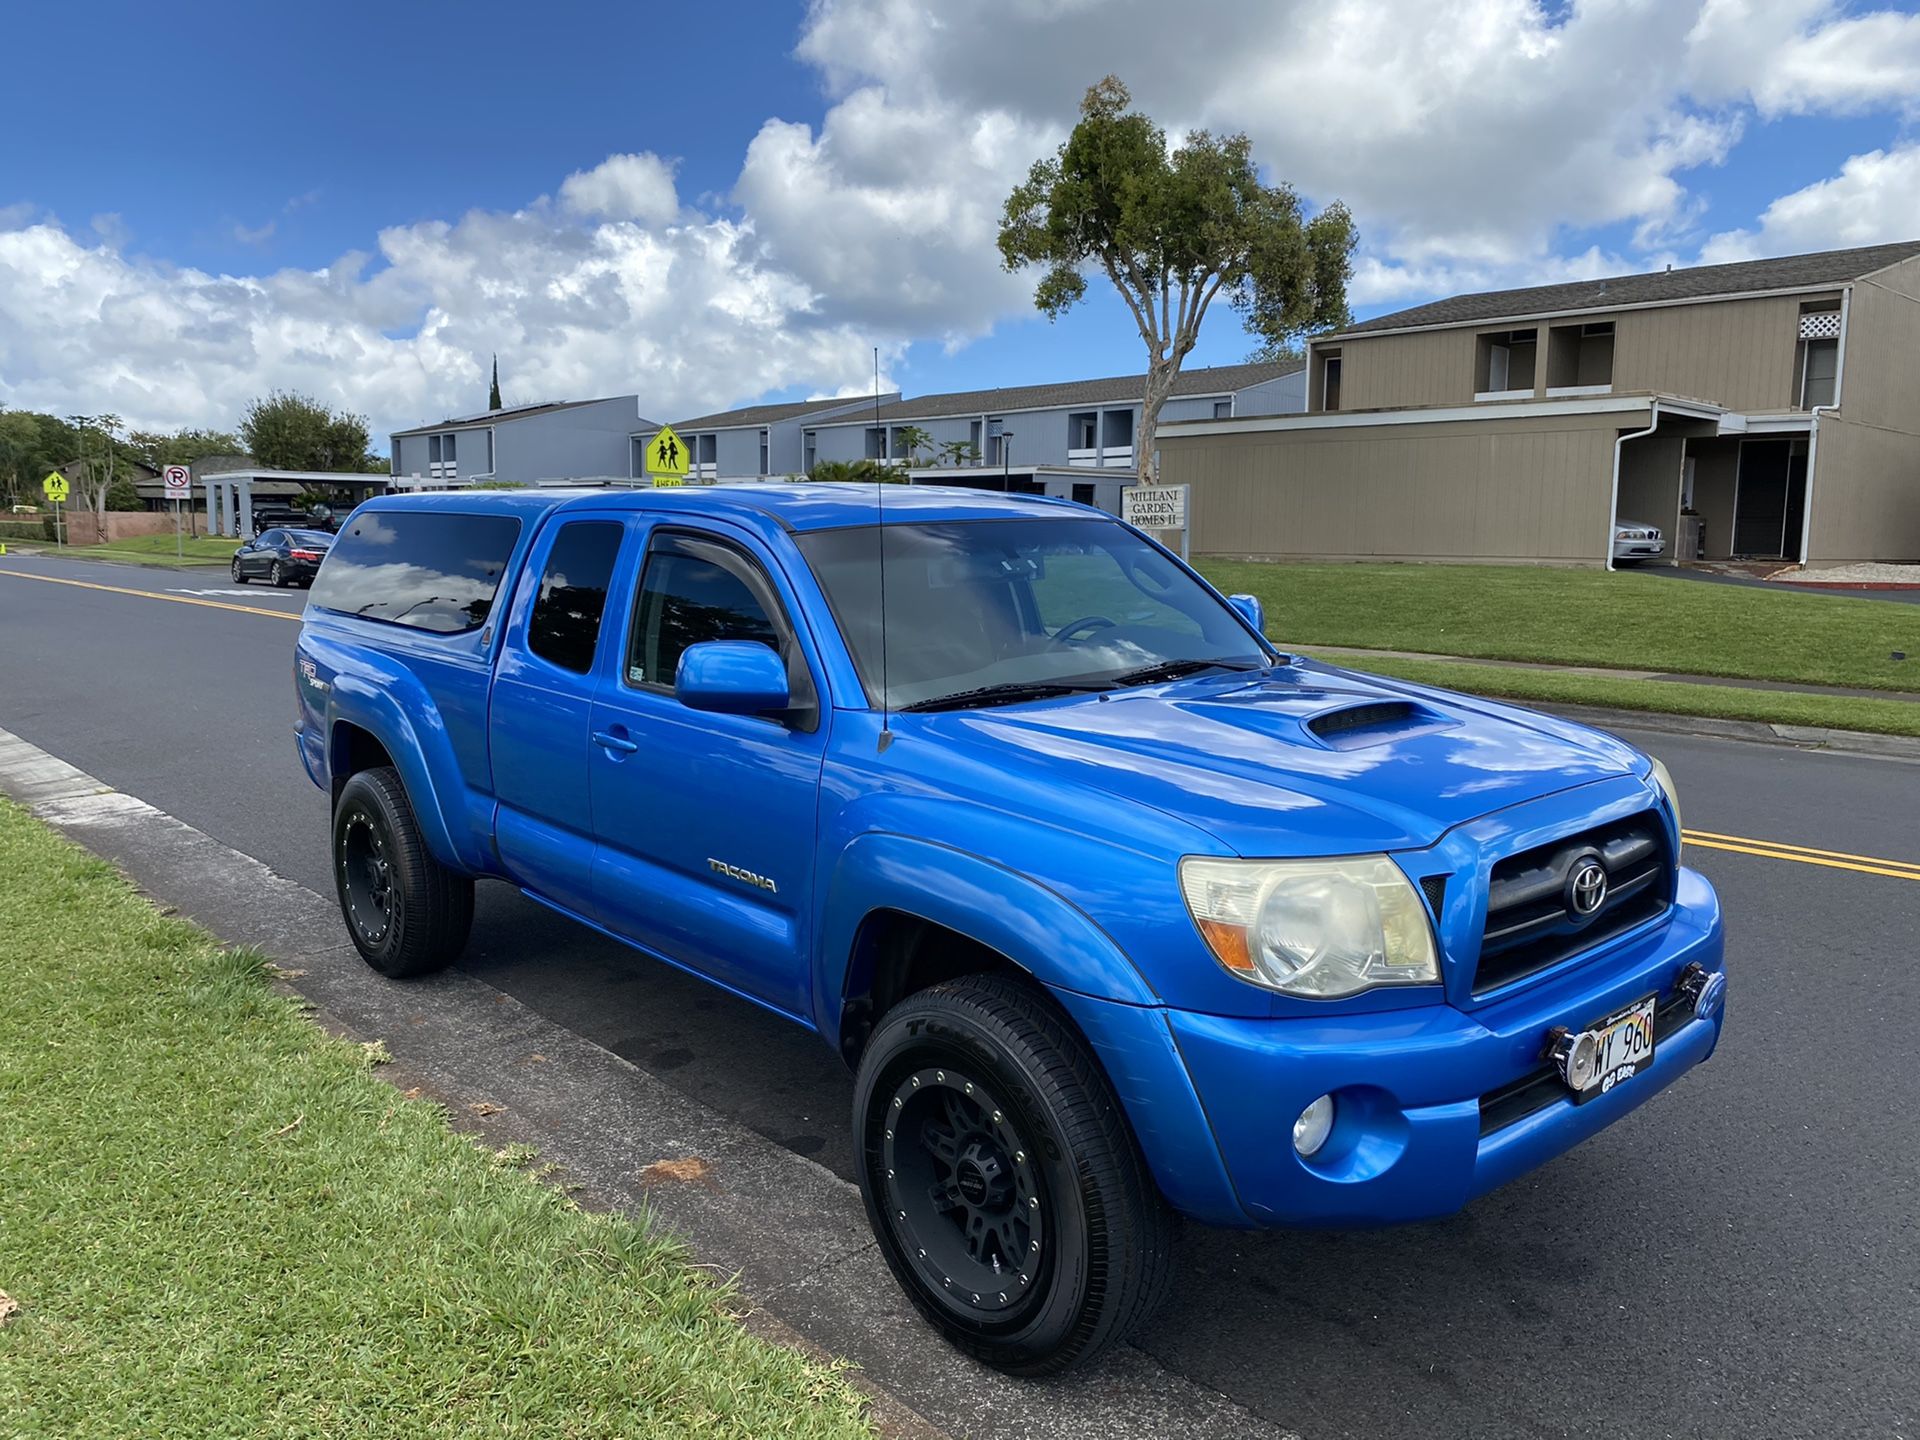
[392,396,657,490]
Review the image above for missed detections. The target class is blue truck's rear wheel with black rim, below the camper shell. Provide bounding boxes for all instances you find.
[334,766,474,979]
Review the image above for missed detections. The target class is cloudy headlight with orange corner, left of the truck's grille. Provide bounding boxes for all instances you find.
[1181,854,1440,1000]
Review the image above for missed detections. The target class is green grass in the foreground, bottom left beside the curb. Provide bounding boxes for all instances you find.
[0,801,870,1440]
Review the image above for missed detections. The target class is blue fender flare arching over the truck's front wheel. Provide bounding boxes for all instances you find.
[814,831,1162,1037]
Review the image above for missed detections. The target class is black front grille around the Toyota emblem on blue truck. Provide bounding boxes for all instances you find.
[1473,810,1674,995]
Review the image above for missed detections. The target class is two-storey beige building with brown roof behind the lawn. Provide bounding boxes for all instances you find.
[1160,240,1920,566]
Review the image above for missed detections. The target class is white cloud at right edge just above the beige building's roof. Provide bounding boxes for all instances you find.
[1701,144,1920,265]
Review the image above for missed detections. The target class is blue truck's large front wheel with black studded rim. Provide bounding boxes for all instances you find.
[854,975,1173,1375]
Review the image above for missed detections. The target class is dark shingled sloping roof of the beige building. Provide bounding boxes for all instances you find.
[1327,240,1920,340]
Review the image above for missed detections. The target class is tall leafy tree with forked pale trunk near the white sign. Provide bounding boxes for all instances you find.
[1000,75,1356,482]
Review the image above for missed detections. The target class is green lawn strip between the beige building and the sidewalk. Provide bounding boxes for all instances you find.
[1200,561,1920,695]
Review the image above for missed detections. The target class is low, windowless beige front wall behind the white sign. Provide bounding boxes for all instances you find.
[1160,415,1620,564]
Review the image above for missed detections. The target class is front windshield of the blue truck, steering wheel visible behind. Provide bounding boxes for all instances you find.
[799,518,1271,710]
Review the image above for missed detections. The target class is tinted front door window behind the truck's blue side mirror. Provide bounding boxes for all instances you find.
[626,536,780,685]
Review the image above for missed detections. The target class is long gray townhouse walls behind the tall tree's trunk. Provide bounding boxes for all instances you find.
[801,361,1306,470]
